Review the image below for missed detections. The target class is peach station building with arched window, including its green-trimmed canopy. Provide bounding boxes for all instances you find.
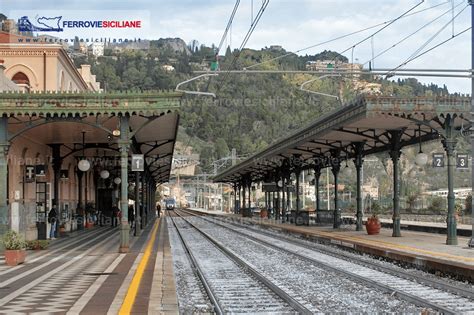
[0,33,181,251]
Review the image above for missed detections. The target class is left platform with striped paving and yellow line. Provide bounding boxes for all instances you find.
[0,219,179,314]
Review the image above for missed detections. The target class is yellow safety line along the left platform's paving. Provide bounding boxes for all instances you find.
[119,219,160,315]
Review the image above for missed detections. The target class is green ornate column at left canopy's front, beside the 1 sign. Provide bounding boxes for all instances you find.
[118,116,130,253]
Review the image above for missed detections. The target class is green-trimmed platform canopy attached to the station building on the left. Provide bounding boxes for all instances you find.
[0,91,182,183]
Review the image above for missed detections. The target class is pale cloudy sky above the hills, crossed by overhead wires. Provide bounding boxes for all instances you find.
[0,0,471,94]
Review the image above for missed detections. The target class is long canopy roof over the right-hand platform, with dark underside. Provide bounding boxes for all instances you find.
[214,96,471,183]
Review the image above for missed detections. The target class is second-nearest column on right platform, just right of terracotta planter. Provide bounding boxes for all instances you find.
[389,130,403,237]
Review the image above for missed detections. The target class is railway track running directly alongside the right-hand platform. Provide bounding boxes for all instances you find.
[182,211,474,314]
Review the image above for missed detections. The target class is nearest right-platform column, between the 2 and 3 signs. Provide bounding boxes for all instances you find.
[442,114,458,245]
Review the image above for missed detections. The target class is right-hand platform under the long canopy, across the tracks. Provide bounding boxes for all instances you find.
[190,208,474,281]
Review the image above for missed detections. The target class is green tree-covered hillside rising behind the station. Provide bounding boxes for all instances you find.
[70,39,469,200]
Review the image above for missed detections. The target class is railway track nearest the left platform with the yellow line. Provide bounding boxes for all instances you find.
[170,211,311,314]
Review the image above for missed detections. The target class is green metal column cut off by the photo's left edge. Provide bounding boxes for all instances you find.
[0,117,9,250]
